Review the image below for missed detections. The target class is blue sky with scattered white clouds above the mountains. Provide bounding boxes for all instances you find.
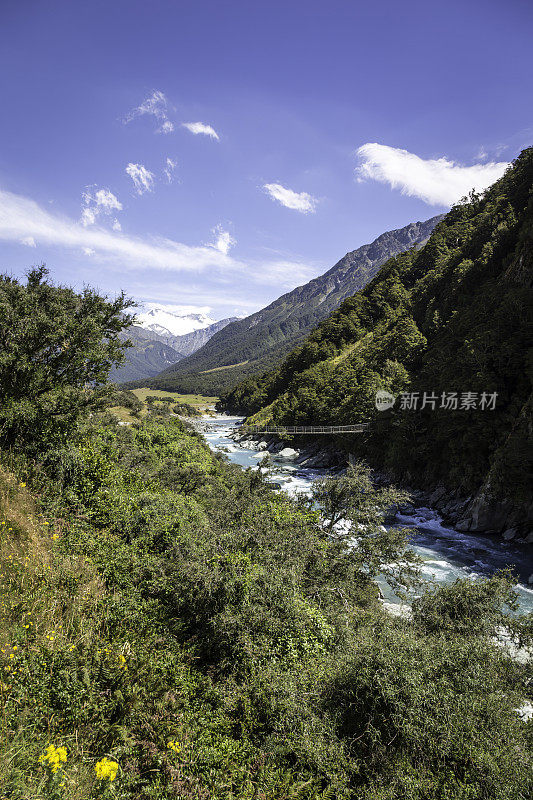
[0,0,533,319]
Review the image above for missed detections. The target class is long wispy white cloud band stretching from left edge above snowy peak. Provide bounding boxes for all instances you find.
[0,189,320,300]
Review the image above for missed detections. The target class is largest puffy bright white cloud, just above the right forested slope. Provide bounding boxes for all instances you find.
[356,142,508,206]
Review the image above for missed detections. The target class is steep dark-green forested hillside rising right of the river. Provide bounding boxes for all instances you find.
[220,148,533,530]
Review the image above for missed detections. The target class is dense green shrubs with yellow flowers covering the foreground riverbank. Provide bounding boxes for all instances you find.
[0,404,533,800]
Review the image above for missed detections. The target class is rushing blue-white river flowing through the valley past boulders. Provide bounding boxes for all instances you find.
[200,416,533,613]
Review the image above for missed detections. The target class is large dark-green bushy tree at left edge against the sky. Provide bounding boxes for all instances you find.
[0,265,133,450]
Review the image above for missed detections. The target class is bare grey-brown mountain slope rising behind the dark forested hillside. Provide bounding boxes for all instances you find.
[124,216,441,396]
